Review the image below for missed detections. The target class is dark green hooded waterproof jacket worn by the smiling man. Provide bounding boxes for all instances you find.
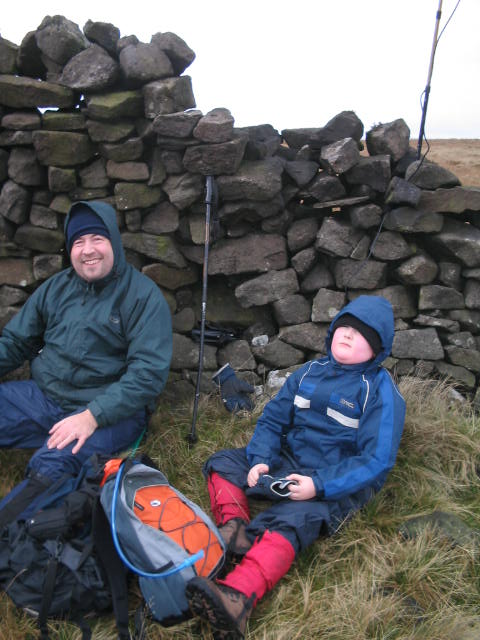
[0,201,172,427]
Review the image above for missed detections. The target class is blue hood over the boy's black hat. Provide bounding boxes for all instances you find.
[325,296,395,364]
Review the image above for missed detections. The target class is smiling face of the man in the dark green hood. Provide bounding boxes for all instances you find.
[70,233,114,282]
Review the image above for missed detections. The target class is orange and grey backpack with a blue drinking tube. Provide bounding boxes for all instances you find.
[99,456,225,637]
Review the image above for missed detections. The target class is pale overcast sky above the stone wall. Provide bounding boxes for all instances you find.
[0,0,480,139]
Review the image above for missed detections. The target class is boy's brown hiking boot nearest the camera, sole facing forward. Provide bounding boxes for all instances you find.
[186,577,255,640]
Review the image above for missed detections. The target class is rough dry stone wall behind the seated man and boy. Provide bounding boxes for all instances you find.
[0,16,480,397]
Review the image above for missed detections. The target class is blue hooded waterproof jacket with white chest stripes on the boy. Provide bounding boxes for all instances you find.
[247,296,405,500]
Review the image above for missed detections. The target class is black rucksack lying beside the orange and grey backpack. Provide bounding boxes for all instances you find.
[0,456,129,640]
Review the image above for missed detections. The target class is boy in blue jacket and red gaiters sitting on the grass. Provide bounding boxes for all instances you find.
[187,296,405,640]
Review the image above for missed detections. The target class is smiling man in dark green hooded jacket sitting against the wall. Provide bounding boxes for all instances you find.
[0,201,172,524]
